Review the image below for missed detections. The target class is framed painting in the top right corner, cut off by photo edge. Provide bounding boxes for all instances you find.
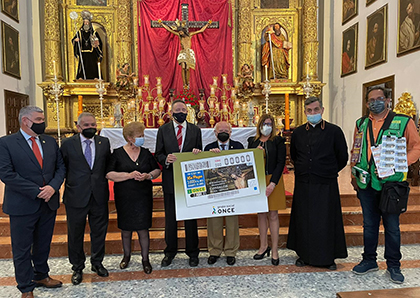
[397,0,420,57]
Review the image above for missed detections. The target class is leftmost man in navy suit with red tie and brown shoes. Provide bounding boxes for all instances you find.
[0,106,66,297]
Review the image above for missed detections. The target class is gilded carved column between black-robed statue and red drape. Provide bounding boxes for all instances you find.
[115,0,135,69]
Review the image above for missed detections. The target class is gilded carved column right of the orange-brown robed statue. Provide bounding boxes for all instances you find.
[302,0,319,80]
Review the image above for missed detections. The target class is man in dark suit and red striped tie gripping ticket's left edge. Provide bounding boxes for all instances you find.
[155,100,203,267]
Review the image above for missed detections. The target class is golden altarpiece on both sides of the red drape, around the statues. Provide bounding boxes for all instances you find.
[39,0,324,133]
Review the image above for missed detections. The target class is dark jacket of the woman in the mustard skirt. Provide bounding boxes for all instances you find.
[248,136,286,185]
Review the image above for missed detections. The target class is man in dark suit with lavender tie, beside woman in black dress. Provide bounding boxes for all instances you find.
[61,112,111,285]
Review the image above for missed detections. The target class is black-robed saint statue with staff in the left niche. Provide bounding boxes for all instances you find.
[71,10,103,80]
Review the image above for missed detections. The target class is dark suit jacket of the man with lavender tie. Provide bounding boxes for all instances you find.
[61,134,111,208]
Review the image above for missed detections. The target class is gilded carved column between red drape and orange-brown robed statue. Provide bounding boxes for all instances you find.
[237,0,253,69]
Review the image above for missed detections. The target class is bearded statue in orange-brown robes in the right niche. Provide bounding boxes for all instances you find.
[261,23,292,79]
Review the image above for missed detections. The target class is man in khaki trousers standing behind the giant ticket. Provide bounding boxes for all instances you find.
[204,121,244,265]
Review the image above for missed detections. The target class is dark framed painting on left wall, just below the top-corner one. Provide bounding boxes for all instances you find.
[1,21,21,79]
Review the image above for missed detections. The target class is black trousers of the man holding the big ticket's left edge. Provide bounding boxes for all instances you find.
[164,193,200,258]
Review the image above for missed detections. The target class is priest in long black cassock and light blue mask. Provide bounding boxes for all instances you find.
[287,97,348,270]
